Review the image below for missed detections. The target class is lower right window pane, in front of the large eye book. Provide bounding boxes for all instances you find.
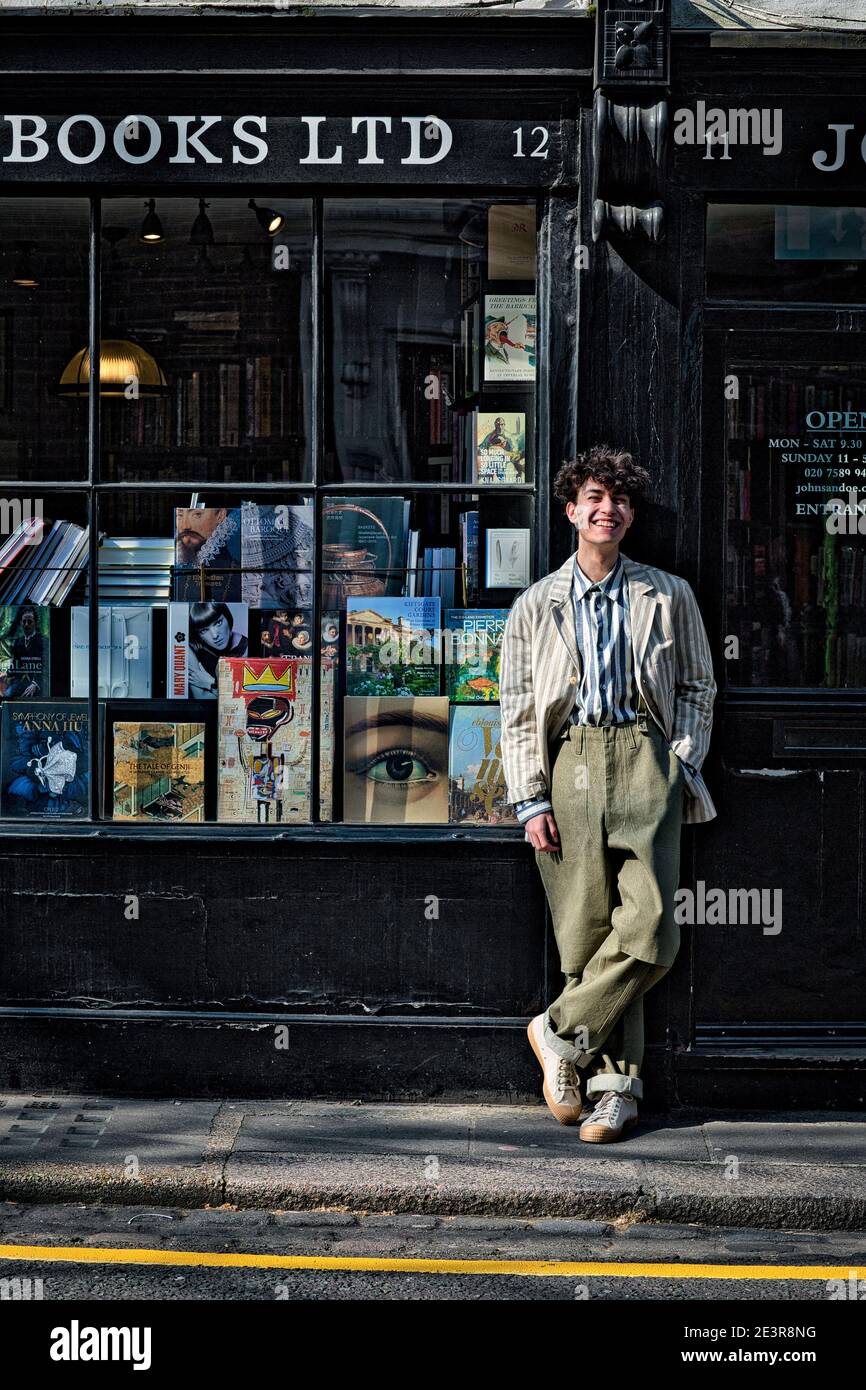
[321,488,535,826]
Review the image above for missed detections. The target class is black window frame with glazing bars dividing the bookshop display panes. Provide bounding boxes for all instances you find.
[0,181,580,844]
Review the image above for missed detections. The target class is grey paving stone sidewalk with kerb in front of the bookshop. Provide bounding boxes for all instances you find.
[0,1093,866,1230]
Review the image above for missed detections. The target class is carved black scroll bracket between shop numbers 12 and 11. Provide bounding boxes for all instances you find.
[592,0,670,243]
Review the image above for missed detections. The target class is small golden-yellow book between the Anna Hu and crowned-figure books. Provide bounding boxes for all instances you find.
[113,720,204,824]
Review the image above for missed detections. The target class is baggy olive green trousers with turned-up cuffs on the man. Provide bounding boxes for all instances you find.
[535,716,685,1099]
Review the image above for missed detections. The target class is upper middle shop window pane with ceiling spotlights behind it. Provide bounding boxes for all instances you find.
[100,193,313,484]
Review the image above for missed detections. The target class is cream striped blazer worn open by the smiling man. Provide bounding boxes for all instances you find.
[499,550,717,823]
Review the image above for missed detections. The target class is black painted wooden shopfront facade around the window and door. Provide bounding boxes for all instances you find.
[0,14,866,1108]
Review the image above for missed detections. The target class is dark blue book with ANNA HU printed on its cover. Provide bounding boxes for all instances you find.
[0,701,90,820]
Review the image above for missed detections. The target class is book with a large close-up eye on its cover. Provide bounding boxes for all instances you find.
[343,695,448,826]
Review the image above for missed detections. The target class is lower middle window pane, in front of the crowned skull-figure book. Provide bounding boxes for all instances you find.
[99,489,317,828]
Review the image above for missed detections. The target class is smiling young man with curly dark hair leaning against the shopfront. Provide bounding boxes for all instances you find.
[500,445,716,1143]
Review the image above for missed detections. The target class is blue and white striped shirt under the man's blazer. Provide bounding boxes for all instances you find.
[516,555,639,824]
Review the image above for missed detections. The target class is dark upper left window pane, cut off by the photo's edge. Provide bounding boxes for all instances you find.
[0,197,90,482]
